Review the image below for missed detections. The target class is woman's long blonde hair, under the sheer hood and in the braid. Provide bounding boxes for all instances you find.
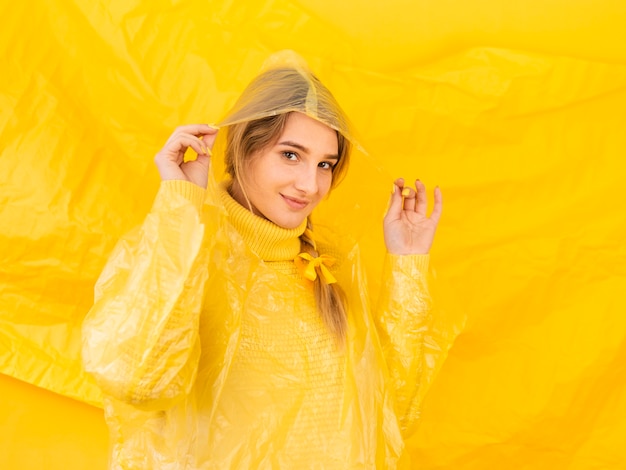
[225,69,351,344]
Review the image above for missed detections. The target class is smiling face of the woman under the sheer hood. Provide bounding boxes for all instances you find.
[233,113,339,228]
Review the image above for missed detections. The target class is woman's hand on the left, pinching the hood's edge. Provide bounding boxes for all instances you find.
[154,124,218,188]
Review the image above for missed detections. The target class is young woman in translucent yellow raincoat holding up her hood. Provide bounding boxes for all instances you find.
[83,57,442,469]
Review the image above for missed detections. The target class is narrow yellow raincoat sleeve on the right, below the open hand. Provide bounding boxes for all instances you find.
[376,253,434,436]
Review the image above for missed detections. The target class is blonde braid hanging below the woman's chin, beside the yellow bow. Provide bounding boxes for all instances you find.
[300,220,348,344]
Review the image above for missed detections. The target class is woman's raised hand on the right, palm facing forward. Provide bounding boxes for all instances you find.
[383,178,443,255]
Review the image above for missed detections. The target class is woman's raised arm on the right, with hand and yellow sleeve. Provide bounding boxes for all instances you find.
[376,179,442,435]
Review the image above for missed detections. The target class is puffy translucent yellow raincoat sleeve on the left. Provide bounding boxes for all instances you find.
[83,181,206,409]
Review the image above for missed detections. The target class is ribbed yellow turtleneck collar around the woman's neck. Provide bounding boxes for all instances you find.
[219,184,306,261]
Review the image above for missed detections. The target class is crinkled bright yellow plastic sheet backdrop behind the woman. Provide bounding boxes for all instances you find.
[0,0,626,470]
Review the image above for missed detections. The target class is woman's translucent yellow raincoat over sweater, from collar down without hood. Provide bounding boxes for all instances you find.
[83,181,444,469]
